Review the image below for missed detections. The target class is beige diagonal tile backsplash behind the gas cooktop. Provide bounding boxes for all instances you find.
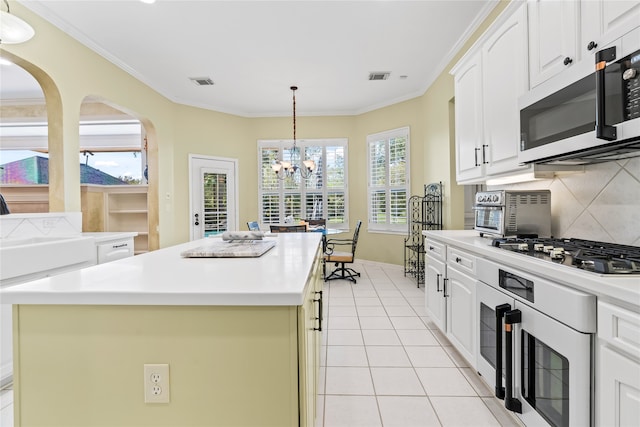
[491,157,640,246]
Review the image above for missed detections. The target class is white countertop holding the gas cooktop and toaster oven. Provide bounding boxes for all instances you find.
[422,230,640,311]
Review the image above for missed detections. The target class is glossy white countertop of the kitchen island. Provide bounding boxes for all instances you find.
[2,233,322,306]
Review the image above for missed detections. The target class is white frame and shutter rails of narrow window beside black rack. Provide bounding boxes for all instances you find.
[366,126,411,234]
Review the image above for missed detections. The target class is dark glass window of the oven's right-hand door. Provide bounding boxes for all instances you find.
[522,330,569,427]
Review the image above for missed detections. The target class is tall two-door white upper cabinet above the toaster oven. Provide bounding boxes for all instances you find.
[452,5,530,184]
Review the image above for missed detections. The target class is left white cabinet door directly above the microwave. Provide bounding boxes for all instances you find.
[527,0,580,88]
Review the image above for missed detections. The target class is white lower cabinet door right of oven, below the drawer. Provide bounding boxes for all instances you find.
[597,346,640,427]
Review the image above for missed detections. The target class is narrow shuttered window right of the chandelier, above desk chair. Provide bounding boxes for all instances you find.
[367,127,409,233]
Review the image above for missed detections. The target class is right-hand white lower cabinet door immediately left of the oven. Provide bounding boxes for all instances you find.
[445,268,476,366]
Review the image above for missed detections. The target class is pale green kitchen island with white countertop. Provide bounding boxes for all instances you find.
[3,233,322,426]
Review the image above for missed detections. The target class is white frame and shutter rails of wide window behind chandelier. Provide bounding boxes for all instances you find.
[257,138,349,230]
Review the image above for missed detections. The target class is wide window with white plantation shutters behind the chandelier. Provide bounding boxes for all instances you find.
[258,139,349,228]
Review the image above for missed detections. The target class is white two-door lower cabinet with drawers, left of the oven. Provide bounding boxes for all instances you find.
[425,241,476,365]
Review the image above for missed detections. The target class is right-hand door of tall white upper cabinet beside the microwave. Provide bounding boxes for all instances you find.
[482,6,528,175]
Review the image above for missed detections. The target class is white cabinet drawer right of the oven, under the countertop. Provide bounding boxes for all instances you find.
[598,302,640,357]
